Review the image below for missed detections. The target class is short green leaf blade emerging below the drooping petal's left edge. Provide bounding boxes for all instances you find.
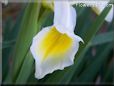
[16,52,34,84]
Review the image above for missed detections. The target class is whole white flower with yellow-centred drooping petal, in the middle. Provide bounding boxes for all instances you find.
[30,1,83,79]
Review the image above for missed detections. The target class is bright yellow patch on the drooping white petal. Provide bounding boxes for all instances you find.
[39,27,72,60]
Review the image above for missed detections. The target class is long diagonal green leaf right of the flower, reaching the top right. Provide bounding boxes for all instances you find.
[67,7,111,83]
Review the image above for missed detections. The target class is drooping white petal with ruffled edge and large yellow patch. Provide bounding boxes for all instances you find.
[31,26,81,79]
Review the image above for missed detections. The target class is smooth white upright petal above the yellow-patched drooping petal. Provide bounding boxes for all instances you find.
[54,1,76,32]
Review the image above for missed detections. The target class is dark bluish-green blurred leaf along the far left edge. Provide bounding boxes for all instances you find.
[2,9,25,81]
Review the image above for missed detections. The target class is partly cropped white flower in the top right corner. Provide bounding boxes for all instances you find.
[70,0,114,22]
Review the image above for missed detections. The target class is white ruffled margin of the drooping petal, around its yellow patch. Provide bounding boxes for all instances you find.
[31,26,82,79]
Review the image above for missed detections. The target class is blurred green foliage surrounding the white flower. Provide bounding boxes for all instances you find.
[2,3,114,84]
